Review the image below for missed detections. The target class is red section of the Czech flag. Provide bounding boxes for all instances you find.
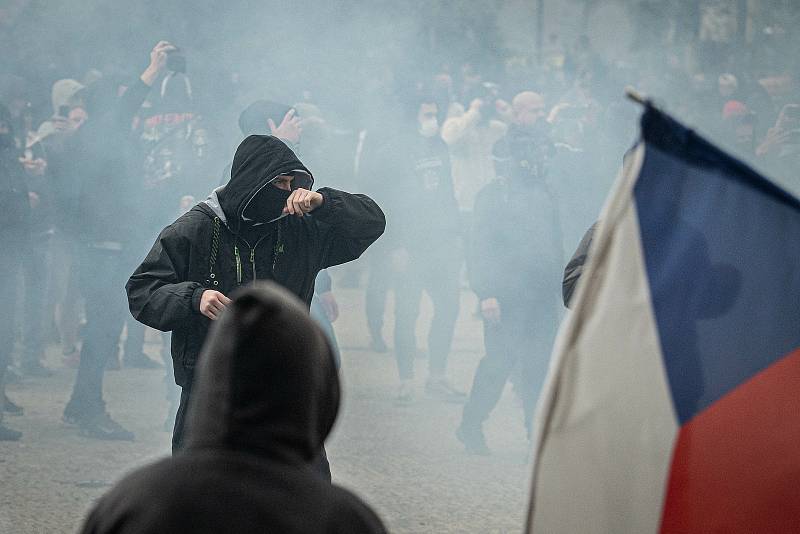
[661,349,800,533]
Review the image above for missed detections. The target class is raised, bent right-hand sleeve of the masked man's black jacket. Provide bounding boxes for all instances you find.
[313,187,386,268]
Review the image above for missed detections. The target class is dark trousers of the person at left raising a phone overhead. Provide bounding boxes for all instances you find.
[67,247,131,414]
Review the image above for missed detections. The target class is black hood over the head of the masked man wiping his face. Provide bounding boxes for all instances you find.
[217,135,313,234]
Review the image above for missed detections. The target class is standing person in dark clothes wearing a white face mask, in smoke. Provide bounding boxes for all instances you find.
[367,98,466,403]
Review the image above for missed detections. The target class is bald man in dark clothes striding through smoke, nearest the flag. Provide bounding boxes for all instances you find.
[456,92,562,454]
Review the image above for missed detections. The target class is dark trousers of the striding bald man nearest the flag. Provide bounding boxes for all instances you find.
[463,299,557,432]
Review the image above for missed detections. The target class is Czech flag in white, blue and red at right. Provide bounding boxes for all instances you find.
[527,105,800,534]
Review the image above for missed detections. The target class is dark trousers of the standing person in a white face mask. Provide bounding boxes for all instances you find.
[394,256,460,380]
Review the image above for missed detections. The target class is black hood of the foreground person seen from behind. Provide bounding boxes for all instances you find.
[187,282,339,463]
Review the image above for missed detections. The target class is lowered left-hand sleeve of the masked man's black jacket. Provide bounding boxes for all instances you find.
[125,225,205,332]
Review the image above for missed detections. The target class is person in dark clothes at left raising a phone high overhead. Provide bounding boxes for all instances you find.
[64,41,174,440]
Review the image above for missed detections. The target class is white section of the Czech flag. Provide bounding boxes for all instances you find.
[528,144,678,534]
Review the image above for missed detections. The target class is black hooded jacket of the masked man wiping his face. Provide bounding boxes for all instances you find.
[126,135,385,386]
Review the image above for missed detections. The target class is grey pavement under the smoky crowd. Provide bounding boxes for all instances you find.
[0,289,530,534]
